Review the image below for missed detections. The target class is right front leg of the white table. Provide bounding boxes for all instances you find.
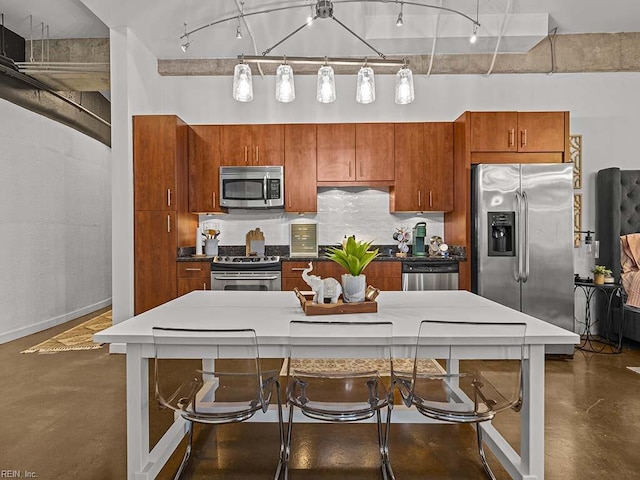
[520,345,544,480]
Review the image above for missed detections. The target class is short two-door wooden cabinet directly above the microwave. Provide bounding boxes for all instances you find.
[220,124,284,166]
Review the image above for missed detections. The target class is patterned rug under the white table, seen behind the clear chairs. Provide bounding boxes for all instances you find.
[280,358,445,377]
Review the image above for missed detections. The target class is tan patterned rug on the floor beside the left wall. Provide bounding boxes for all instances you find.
[20,310,113,353]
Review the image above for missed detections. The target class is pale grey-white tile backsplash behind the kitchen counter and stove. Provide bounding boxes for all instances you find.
[200,187,447,246]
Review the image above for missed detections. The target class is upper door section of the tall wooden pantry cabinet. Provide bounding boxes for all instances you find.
[133,115,187,210]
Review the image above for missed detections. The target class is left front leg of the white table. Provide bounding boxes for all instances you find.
[127,344,149,480]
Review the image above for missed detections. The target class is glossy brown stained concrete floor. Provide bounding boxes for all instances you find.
[0,311,640,480]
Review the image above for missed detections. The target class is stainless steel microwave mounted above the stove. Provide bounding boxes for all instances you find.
[220,166,284,208]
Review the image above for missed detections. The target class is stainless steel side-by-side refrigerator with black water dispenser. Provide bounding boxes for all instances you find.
[471,163,574,354]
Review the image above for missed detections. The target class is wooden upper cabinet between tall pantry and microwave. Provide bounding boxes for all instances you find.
[189,125,222,213]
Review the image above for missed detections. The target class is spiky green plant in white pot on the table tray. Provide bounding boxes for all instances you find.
[326,236,379,302]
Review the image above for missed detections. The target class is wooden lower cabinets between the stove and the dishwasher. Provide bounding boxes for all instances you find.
[282,260,402,291]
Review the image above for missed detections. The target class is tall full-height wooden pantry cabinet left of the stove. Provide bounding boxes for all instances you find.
[133,115,198,315]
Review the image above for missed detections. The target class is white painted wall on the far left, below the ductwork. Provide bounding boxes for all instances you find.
[0,100,111,343]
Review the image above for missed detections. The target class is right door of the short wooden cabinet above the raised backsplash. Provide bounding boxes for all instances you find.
[356,123,395,182]
